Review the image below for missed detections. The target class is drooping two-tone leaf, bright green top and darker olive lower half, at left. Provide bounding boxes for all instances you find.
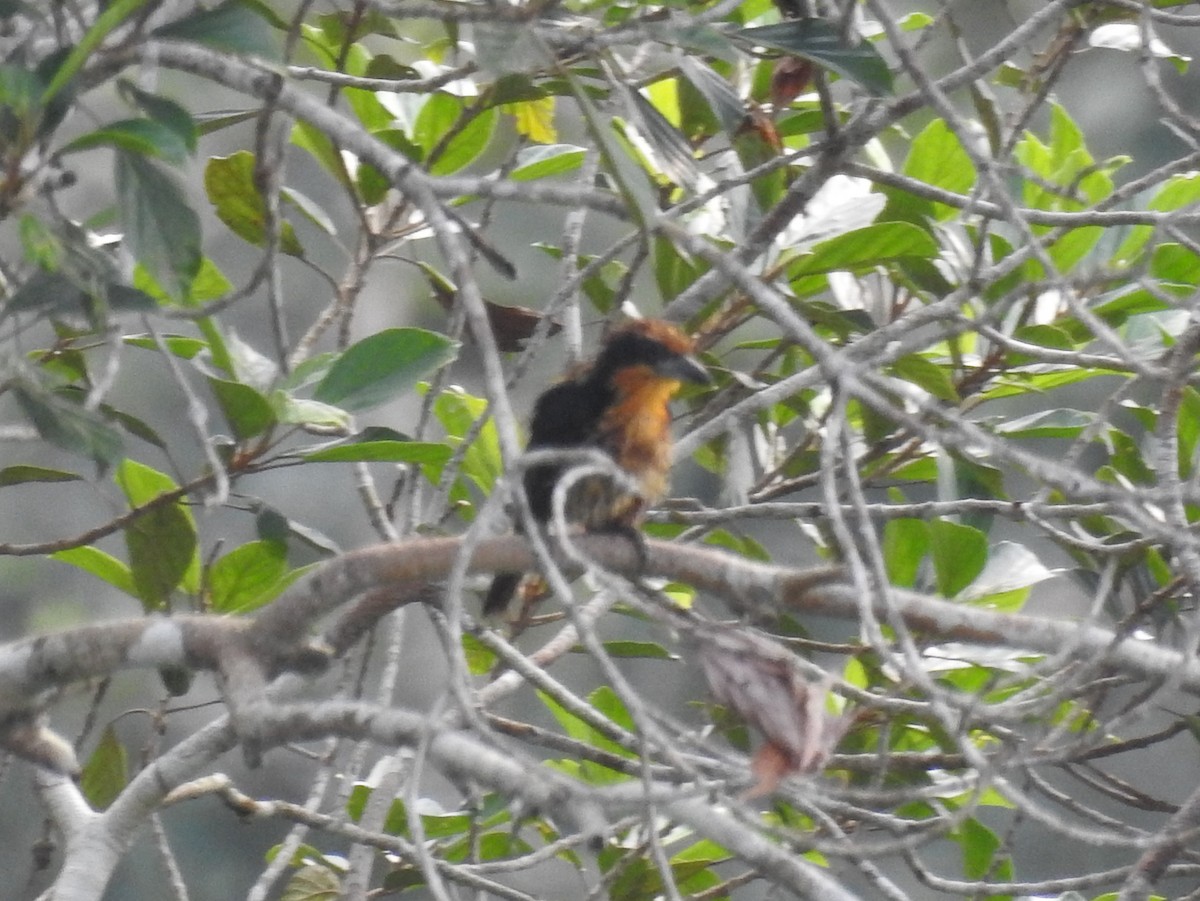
[116,459,199,611]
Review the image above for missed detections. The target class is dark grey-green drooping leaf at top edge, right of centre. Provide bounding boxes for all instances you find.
[727,18,892,95]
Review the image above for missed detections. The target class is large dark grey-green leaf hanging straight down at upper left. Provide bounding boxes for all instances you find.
[115,150,200,299]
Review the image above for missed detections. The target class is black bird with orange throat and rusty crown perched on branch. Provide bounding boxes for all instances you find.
[484,319,710,615]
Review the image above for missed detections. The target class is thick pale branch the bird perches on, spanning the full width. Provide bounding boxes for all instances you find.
[0,536,1200,763]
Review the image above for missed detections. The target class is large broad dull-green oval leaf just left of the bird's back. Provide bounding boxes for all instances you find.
[313,328,458,412]
